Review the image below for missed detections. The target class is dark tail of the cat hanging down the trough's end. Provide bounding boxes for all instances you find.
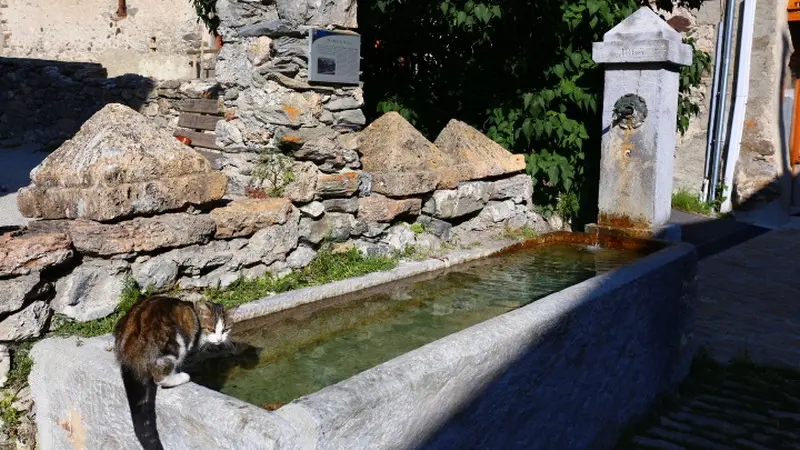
[122,364,164,450]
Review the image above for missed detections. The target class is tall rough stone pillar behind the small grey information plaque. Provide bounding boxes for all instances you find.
[209,0,366,195]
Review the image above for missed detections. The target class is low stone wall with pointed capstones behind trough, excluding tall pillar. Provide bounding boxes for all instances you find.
[0,101,551,380]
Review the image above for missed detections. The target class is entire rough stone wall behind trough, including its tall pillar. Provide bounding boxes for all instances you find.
[0,0,562,392]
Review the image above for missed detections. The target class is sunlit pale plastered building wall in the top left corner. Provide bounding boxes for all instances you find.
[0,0,215,80]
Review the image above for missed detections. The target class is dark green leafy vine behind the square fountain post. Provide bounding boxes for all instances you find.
[359,0,710,225]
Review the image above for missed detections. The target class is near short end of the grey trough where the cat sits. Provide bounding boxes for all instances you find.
[28,334,302,450]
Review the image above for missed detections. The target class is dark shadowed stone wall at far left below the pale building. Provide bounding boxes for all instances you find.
[0,58,155,149]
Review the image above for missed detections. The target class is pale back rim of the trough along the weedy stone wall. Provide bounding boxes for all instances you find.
[233,241,517,322]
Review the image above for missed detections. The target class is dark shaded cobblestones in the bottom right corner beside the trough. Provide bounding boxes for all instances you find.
[616,357,800,450]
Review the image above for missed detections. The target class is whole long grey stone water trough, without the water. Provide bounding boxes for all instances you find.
[30,234,696,450]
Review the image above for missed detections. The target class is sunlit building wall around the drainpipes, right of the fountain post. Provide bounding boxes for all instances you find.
[665,0,792,211]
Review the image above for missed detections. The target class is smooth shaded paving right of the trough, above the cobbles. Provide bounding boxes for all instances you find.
[696,226,800,368]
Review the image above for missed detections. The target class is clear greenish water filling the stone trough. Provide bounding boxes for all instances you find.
[191,244,644,406]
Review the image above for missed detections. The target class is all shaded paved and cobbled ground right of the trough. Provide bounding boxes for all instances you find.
[617,223,800,450]
